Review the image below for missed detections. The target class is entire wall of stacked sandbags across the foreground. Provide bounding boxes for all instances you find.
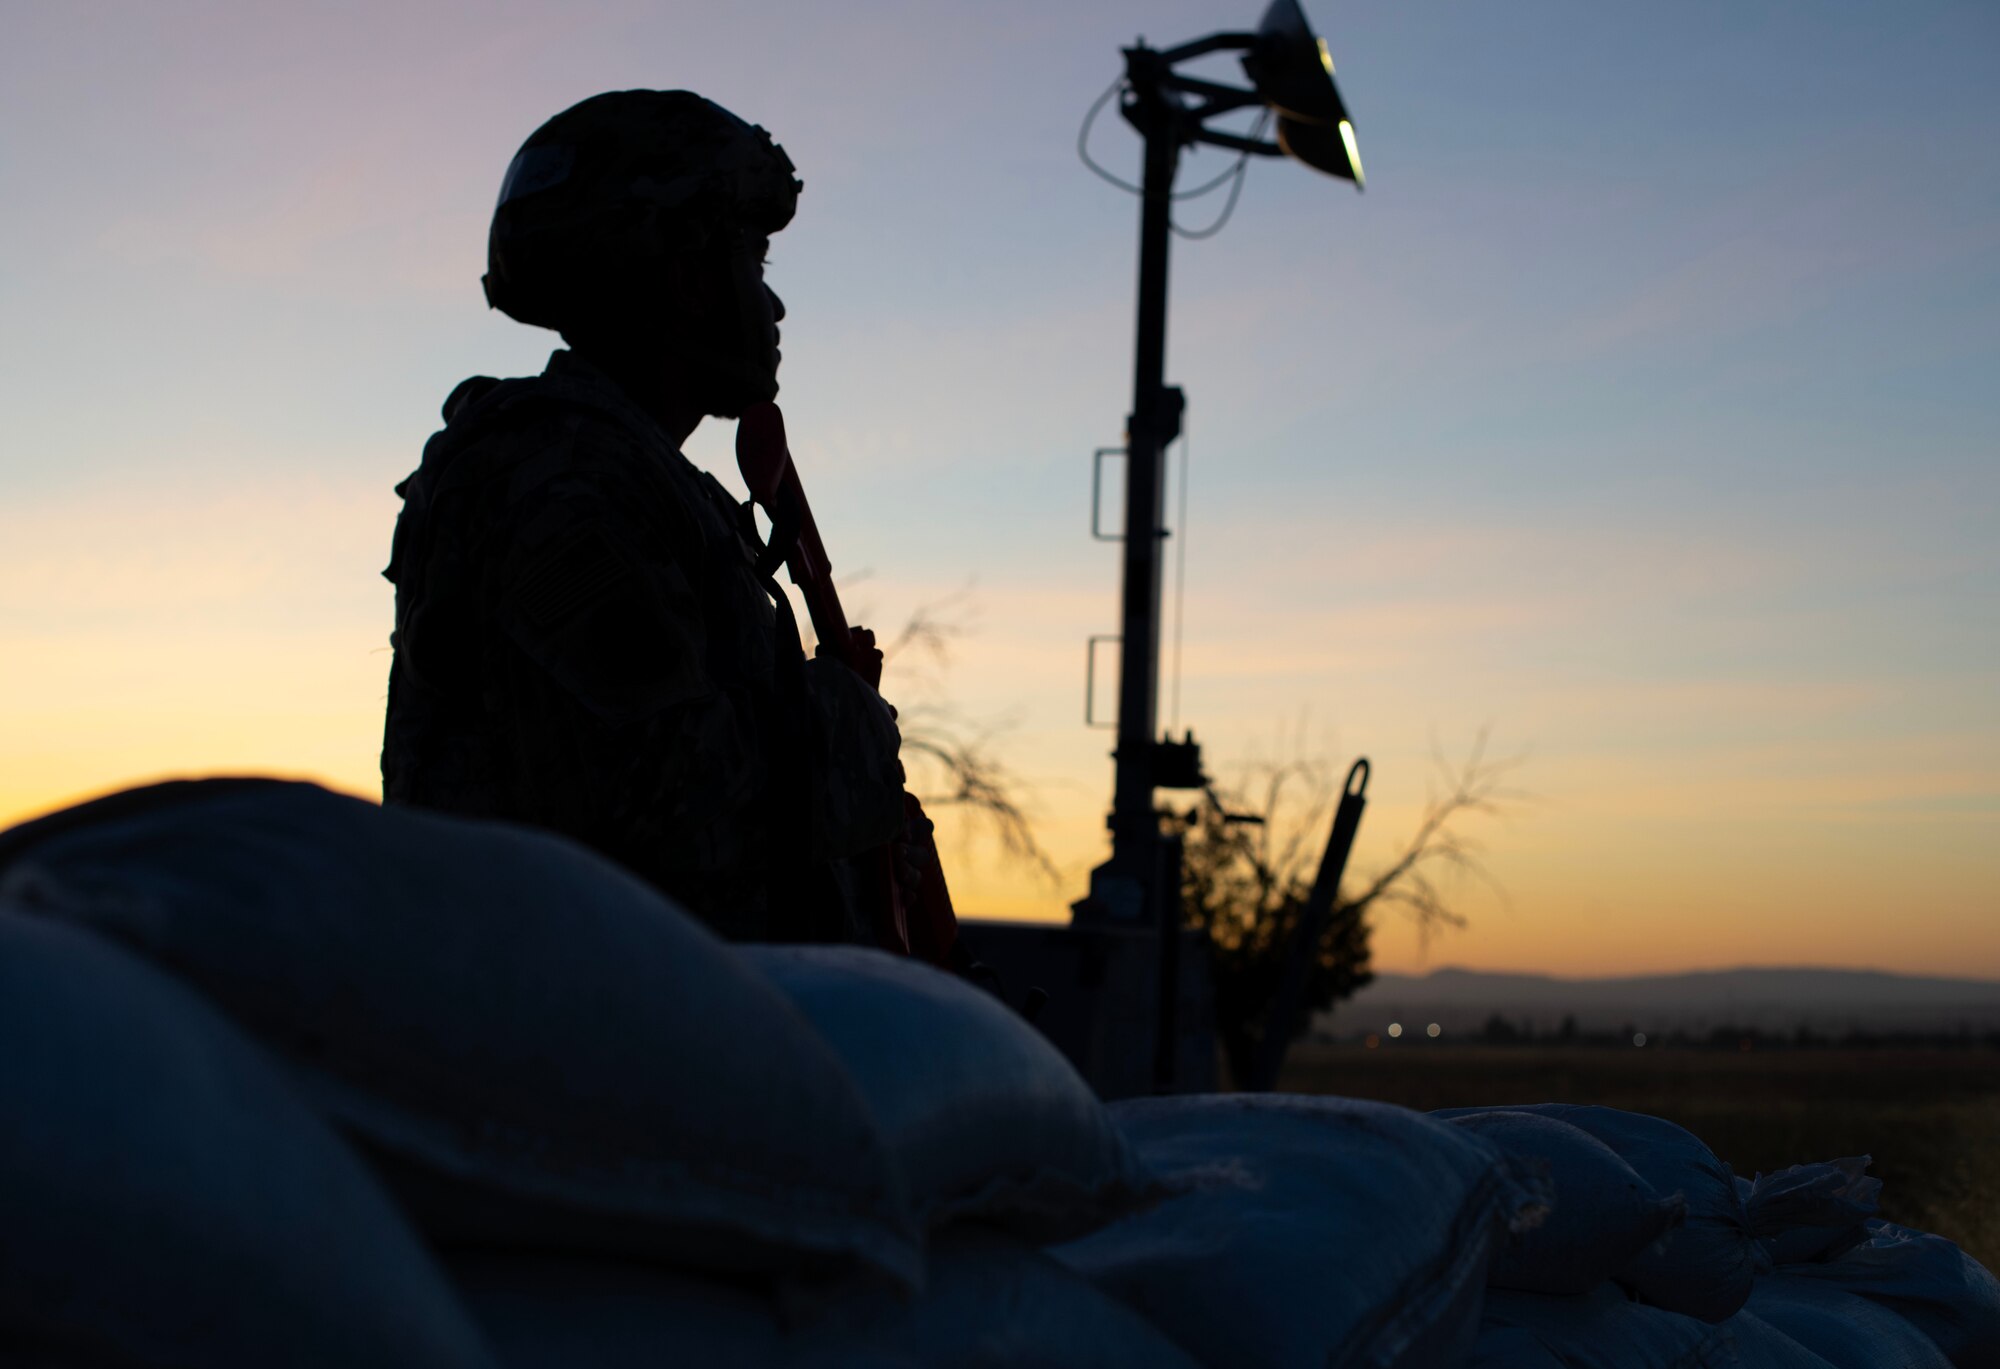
[0,781,2000,1369]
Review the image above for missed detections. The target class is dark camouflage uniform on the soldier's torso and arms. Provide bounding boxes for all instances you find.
[382,350,902,941]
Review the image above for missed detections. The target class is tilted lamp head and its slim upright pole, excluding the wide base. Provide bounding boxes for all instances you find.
[1072,0,1362,1087]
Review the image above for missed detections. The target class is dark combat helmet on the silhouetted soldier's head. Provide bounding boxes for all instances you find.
[482,90,804,328]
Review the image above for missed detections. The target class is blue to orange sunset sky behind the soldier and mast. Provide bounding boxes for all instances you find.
[0,0,2000,979]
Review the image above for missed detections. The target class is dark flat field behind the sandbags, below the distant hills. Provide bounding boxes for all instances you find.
[1280,1043,2000,1269]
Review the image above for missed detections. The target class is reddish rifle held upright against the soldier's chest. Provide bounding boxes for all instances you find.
[736,402,958,967]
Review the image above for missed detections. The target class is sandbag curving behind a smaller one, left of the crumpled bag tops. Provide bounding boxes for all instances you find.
[1432,1103,1764,1321]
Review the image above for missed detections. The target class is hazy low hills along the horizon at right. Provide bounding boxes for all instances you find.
[1316,969,2000,1035]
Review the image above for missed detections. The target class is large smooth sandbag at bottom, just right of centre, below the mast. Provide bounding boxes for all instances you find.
[1050,1095,1548,1369]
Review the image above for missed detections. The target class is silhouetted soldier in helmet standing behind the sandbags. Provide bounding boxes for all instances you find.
[382,90,902,939]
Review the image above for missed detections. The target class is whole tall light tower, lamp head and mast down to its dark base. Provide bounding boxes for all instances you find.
[968,0,1364,1095]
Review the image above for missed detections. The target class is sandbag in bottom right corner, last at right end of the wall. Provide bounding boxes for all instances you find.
[1766,1219,2000,1369]
